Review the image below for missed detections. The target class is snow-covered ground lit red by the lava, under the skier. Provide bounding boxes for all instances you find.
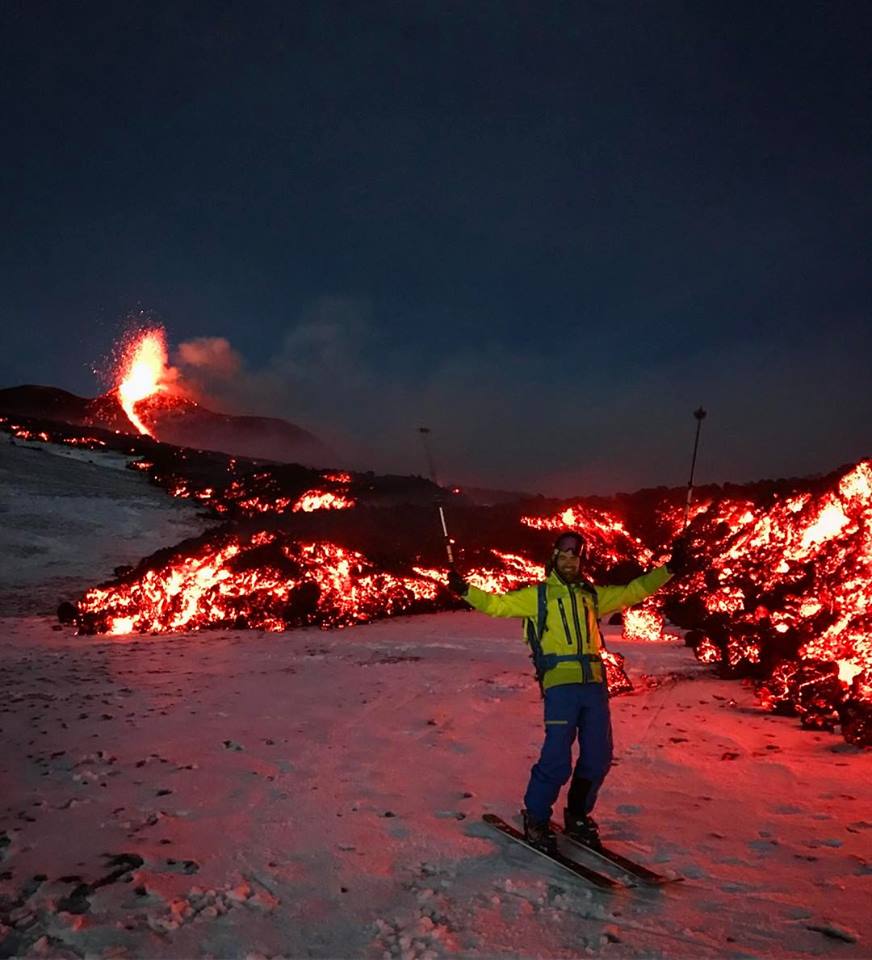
[0,436,872,958]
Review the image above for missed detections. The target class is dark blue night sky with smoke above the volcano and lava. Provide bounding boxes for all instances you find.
[0,0,872,494]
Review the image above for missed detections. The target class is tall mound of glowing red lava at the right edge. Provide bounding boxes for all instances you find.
[668,460,872,745]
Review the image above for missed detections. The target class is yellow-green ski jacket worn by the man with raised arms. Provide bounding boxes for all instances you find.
[463,567,672,690]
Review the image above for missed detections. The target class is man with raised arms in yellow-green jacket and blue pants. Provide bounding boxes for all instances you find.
[448,531,688,853]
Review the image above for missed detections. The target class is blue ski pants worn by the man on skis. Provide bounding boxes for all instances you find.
[524,683,612,821]
